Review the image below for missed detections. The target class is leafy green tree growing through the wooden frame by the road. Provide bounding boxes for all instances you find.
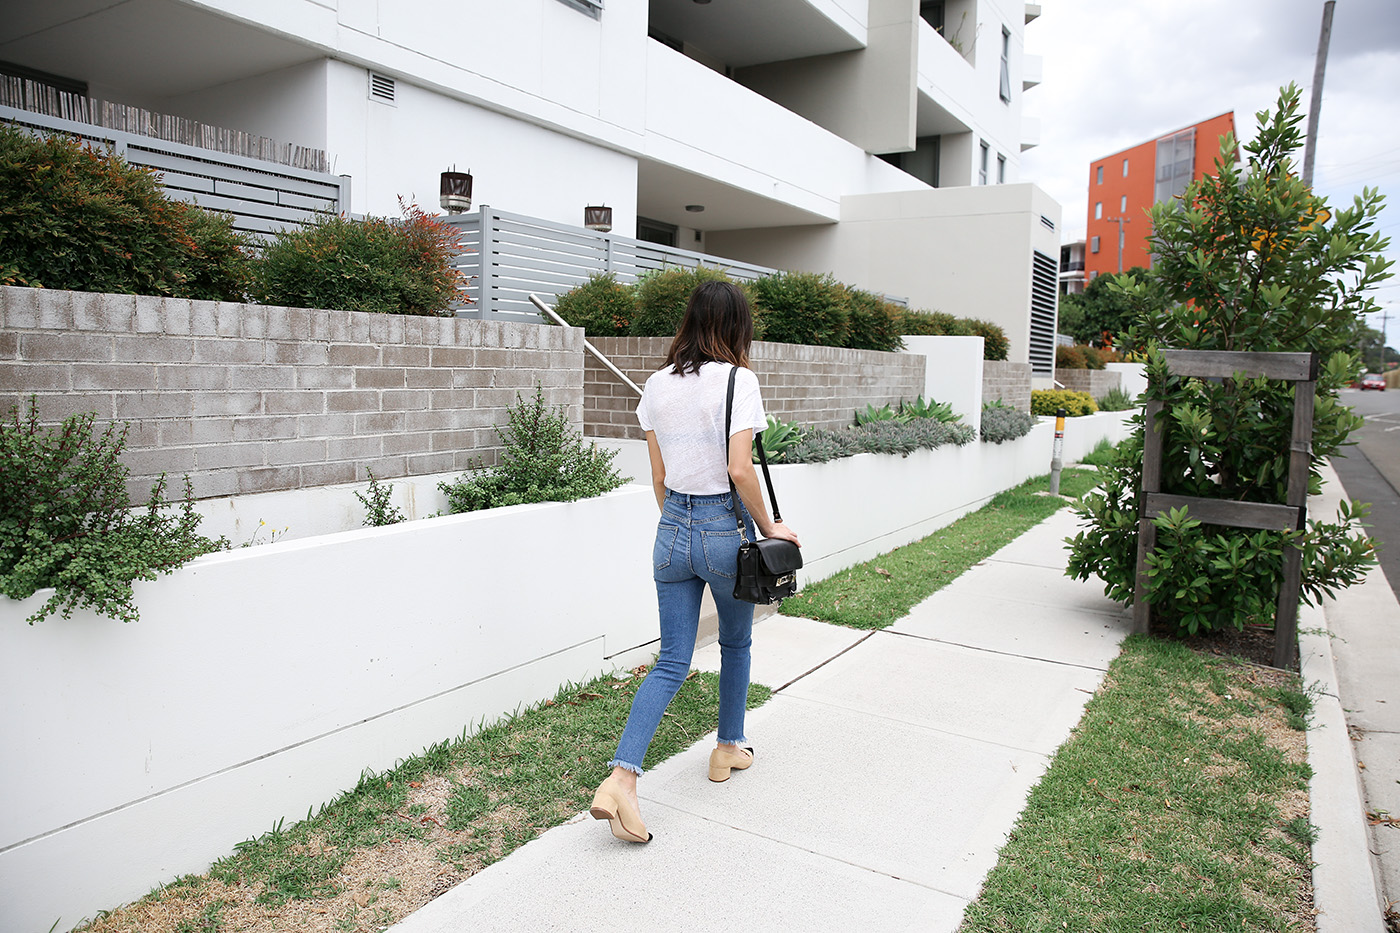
[1067,85,1392,632]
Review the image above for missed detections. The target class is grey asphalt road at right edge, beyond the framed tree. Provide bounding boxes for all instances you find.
[1315,389,1400,598]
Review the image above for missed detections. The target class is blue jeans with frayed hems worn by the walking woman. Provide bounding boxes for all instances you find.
[608,490,755,775]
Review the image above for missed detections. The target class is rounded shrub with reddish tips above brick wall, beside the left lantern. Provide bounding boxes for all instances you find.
[252,205,462,317]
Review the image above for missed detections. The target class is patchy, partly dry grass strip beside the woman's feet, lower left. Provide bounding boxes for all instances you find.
[78,665,771,933]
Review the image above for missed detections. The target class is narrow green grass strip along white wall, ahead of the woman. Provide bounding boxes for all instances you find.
[780,469,1098,629]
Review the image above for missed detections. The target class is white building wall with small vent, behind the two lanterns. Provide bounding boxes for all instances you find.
[328,59,637,224]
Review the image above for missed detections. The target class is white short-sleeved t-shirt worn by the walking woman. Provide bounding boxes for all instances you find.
[637,363,769,496]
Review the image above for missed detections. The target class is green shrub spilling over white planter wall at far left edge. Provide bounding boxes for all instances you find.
[0,399,228,625]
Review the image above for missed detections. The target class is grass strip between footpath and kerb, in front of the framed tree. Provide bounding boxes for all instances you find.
[960,636,1315,933]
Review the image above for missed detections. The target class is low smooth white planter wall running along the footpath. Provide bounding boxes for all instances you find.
[0,412,1128,932]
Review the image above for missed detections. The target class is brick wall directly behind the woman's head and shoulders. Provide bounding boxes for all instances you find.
[584,338,924,440]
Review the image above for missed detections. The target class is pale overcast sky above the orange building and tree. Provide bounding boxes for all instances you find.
[1021,0,1400,340]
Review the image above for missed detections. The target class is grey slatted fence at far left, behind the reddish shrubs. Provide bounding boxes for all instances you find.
[0,106,350,237]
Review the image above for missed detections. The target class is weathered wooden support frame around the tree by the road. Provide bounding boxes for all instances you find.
[1133,344,1317,667]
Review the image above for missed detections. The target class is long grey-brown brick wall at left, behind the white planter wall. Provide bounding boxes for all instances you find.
[0,287,584,502]
